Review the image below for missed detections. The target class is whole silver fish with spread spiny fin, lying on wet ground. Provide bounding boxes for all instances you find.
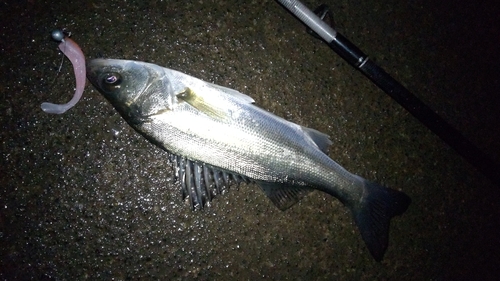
[87,59,411,261]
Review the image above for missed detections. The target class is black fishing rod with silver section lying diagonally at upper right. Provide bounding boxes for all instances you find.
[277,0,500,186]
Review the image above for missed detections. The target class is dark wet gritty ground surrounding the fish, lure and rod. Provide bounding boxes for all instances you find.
[0,0,500,280]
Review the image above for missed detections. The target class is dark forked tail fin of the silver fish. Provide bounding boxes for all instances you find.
[351,181,411,261]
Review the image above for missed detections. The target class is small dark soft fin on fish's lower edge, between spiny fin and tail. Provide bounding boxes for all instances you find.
[258,182,312,211]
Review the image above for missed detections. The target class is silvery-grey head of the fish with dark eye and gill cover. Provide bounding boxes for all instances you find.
[87,59,174,123]
